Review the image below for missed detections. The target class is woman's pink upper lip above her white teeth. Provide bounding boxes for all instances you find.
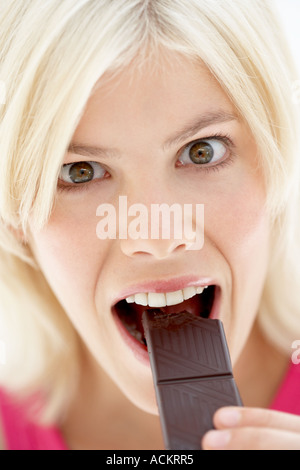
[113,275,216,305]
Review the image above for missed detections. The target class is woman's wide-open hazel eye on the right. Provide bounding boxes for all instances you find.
[179,139,227,165]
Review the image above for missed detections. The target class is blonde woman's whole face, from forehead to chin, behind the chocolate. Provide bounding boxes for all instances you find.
[32,56,269,412]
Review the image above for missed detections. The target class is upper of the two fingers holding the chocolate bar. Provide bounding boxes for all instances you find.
[214,407,300,433]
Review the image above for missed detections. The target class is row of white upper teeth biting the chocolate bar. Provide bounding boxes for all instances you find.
[126,286,207,307]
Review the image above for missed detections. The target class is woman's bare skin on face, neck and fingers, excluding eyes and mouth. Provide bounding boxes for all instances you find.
[27,56,300,449]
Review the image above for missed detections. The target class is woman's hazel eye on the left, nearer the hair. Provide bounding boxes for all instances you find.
[59,162,106,184]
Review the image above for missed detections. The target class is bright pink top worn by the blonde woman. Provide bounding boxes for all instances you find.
[0,364,300,450]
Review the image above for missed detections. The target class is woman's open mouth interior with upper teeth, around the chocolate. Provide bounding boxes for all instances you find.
[113,285,217,346]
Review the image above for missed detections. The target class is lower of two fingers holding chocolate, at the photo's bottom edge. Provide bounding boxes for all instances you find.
[202,427,300,450]
